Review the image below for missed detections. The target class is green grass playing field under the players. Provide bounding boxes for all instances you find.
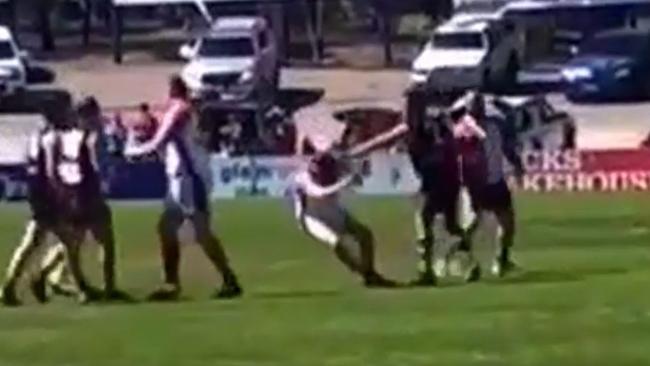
[0,194,650,366]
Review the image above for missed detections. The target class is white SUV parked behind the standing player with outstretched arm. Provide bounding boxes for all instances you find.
[179,17,280,100]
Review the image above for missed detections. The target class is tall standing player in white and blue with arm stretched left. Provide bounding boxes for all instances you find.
[124,76,242,300]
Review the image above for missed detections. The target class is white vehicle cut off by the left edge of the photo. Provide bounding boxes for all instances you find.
[0,26,27,100]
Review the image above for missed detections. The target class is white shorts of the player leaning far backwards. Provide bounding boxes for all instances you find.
[295,200,348,247]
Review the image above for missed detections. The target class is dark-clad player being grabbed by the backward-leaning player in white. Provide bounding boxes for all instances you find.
[406,88,472,286]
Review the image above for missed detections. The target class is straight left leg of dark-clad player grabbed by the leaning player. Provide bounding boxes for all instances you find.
[413,192,436,286]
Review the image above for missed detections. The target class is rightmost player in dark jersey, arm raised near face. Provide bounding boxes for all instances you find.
[448,92,524,276]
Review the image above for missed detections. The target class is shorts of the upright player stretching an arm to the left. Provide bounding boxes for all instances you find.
[165,175,210,215]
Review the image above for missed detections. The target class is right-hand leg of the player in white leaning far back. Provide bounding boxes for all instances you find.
[345,212,396,287]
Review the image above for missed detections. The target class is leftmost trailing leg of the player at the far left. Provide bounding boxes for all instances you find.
[0,220,47,306]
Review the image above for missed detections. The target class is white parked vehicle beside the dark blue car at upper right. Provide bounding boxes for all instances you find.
[411,14,523,91]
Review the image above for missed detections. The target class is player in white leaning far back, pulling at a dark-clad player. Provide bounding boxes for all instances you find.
[293,136,396,287]
